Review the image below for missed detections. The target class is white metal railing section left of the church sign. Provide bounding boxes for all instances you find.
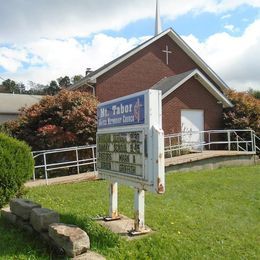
[32,145,96,184]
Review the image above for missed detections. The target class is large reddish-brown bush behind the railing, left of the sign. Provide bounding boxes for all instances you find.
[7,90,98,150]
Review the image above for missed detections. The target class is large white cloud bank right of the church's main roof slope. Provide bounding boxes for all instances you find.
[183,20,260,91]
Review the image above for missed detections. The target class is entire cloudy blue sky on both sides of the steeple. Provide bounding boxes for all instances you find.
[0,0,260,90]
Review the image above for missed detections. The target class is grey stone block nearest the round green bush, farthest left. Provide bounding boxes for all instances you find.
[9,199,41,220]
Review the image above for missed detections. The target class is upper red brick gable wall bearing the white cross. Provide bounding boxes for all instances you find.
[96,35,199,102]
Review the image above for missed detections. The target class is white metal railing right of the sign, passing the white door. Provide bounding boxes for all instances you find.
[164,129,260,157]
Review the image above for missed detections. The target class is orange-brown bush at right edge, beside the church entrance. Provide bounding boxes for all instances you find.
[224,90,260,136]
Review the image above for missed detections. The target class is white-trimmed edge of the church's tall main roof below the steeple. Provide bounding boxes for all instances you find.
[70,28,228,90]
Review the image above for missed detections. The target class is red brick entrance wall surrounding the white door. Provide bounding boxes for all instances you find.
[162,78,223,134]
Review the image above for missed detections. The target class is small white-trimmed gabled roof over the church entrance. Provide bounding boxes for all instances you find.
[152,69,233,107]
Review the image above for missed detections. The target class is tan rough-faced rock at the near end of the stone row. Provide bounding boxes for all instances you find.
[49,223,90,257]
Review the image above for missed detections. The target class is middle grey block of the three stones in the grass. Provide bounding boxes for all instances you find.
[30,208,60,232]
